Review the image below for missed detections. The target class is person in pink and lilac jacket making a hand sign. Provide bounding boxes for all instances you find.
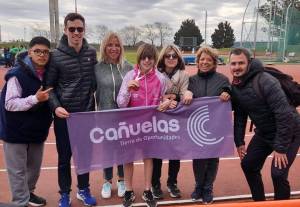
[117,44,166,207]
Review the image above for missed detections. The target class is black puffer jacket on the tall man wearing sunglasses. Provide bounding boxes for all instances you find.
[45,35,97,112]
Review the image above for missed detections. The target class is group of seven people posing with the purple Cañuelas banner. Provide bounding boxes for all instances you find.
[0,10,300,207]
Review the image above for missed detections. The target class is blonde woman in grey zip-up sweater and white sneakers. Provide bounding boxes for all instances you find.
[95,32,132,198]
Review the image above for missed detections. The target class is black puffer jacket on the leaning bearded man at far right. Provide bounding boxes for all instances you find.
[232,59,299,153]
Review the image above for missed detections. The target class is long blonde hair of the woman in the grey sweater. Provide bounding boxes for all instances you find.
[99,32,124,66]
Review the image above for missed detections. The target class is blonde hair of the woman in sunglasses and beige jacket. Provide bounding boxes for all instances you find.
[157,44,185,72]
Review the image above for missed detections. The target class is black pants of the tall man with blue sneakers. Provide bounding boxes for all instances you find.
[54,117,89,193]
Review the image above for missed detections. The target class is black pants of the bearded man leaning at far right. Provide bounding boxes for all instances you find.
[241,135,299,201]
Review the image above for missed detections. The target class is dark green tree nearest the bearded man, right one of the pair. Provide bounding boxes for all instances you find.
[211,21,235,48]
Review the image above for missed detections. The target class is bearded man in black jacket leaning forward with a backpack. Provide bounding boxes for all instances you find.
[230,48,300,201]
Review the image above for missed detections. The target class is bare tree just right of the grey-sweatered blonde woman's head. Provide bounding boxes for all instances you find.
[120,25,141,46]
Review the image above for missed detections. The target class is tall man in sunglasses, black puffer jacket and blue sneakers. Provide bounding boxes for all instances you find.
[46,13,97,207]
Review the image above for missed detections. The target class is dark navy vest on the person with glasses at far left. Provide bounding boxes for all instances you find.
[0,60,52,144]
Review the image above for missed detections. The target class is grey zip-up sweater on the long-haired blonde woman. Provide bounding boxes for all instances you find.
[95,62,133,110]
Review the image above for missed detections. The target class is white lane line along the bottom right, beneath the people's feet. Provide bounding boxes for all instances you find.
[96,191,300,207]
